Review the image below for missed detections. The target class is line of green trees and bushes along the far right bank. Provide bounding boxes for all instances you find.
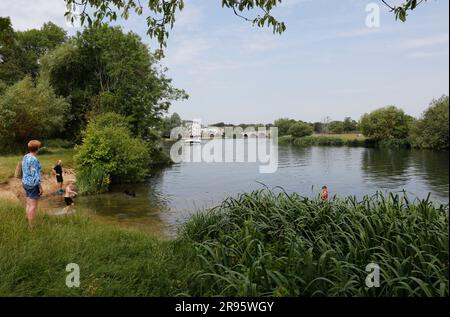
[274,96,449,150]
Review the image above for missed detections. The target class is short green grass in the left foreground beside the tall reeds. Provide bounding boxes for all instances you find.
[0,202,195,296]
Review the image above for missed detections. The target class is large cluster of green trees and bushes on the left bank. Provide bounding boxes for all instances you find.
[0,18,187,191]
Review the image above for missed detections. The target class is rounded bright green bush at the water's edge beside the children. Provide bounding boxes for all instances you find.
[75,113,150,193]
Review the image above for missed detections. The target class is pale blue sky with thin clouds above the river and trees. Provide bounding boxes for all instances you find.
[0,0,449,124]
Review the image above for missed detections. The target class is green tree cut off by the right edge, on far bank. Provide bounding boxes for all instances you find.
[411,96,449,150]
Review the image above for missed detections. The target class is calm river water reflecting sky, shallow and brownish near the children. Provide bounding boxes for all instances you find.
[40,140,449,237]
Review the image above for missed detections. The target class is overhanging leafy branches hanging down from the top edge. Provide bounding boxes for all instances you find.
[65,0,423,48]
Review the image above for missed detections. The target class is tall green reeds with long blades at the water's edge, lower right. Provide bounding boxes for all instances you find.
[181,191,449,296]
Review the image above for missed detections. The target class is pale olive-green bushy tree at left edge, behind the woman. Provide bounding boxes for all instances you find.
[0,77,69,144]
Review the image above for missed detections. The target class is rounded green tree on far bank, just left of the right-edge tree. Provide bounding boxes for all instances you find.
[360,106,413,141]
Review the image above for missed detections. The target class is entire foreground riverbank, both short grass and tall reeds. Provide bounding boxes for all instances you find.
[0,191,449,296]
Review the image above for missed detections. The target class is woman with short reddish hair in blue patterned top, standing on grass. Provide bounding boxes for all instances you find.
[22,140,43,227]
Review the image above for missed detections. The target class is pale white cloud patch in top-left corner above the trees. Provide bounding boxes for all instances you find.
[0,0,67,30]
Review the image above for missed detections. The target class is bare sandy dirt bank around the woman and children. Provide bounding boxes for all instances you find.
[0,169,76,202]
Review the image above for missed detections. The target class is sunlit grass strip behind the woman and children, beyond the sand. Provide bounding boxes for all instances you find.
[0,148,75,184]
